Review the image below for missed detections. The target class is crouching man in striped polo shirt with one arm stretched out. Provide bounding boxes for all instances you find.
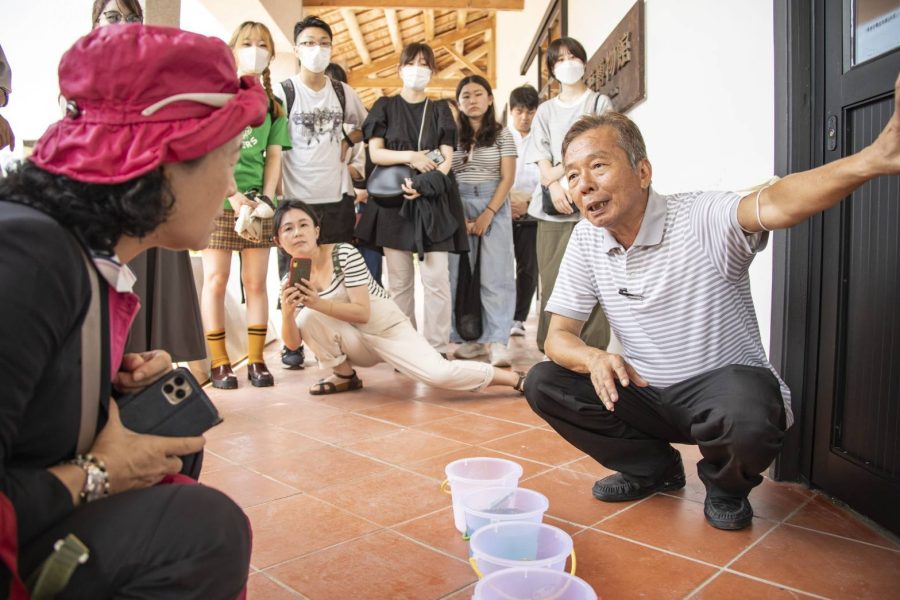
[525,78,900,529]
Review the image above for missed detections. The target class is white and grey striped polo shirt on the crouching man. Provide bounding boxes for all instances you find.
[547,189,794,426]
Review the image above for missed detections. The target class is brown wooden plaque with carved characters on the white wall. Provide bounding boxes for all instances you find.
[584,0,647,112]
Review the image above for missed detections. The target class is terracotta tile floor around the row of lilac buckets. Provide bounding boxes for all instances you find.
[202,323,900,600]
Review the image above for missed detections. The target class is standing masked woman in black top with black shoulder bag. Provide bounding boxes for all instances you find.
[356,43,468,352]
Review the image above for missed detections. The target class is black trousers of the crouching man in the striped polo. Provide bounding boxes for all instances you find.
[525,361,785,496]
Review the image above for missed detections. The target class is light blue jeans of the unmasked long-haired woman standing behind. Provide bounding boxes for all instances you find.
[450,181,516,344]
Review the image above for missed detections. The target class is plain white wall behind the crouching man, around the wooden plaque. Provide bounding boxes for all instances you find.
[497,0,774,348]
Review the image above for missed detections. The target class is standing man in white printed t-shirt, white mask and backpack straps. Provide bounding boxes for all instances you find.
[273,17,368,369]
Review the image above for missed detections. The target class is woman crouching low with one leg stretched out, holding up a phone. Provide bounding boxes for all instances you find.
[274,200,525,395]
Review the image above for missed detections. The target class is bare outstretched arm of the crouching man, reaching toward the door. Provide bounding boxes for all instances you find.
[738,76,900,232]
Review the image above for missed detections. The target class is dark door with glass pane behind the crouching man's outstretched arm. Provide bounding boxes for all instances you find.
[812,0,900,533]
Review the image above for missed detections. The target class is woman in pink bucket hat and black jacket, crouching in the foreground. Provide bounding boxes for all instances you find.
[0,25,268,598]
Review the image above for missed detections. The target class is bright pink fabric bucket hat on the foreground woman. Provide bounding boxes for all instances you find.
[30,25,268,184]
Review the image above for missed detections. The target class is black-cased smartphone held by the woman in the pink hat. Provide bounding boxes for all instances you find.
[116,367,222,437]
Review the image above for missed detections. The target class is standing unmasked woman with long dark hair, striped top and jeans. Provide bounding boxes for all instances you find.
[450,75,516,367]
